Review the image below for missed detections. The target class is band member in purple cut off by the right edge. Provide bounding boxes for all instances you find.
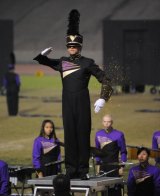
[152,131,160,166]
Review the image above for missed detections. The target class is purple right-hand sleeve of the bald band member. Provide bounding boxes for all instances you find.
[118,134,127,162]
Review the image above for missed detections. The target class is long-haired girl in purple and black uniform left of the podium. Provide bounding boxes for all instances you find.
[32,120,61,178]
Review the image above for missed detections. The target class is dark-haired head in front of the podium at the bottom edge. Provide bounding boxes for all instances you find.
[53,174,70,196]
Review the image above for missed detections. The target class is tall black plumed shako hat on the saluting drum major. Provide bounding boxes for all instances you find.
[66,9,83,47]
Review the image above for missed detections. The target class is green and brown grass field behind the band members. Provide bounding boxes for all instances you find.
[0,74,160,168]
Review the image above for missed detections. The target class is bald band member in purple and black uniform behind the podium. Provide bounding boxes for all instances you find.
[95,114,127,196]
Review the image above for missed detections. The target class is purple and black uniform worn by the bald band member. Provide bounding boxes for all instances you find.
[95,129,127,196]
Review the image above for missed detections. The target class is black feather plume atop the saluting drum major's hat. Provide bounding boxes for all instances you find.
[67,9,80,35]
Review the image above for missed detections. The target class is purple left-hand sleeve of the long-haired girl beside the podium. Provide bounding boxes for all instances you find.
[32,139,42,169]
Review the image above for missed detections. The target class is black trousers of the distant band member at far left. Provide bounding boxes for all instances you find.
[7,91,19,116]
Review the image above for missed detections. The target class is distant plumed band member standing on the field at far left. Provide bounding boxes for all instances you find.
[3,53,20,116]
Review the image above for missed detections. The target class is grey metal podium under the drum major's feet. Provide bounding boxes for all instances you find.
[27,176,123,196]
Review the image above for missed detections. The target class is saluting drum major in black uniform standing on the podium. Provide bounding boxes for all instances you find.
[34,10,112,179]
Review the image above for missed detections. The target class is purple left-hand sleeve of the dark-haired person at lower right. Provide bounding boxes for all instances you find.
[127,169,136,196]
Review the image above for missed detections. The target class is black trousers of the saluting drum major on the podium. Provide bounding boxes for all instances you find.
[62,89,91,174]
